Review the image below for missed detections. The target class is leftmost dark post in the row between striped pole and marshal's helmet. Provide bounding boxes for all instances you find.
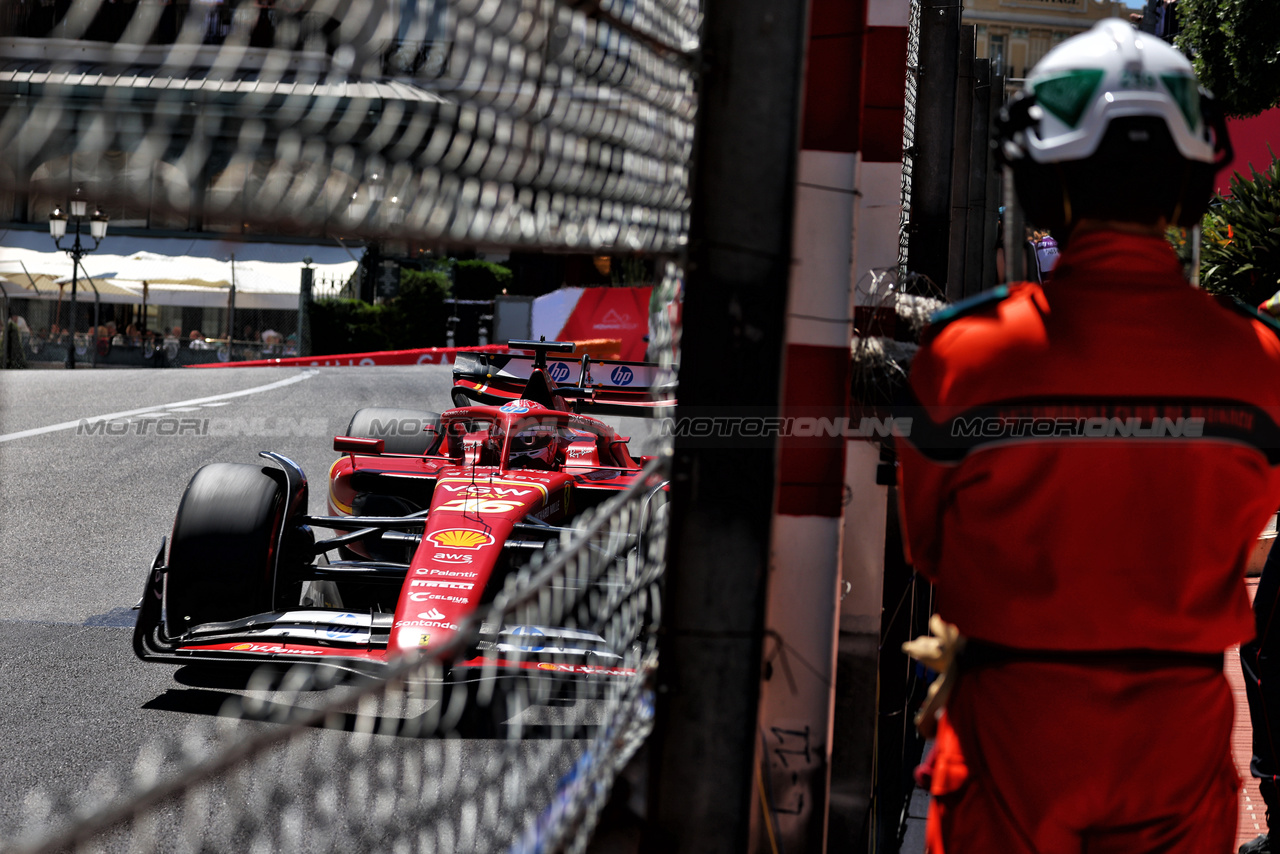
[906,0,960,294]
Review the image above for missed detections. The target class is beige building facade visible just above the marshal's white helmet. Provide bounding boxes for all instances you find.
[963,0,1132,82]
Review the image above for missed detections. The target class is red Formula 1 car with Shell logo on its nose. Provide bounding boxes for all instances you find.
[133,342,666,717]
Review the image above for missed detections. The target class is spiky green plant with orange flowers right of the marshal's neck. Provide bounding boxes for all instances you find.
[1201,154,1280,306]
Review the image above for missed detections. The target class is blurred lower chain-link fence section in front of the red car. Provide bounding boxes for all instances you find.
[0,461,667,854]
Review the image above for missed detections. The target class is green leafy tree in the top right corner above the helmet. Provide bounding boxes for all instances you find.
[1178,0,1280,117]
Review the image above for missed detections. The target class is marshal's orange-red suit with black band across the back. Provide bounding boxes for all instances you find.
[897,230,1280,854]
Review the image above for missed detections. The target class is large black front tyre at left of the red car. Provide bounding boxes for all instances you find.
[164,462,284,638]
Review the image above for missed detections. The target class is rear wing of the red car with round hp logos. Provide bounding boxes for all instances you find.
[452,342,676,417]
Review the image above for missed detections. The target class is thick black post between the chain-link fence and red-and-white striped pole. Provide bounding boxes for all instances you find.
[644,0,809,854]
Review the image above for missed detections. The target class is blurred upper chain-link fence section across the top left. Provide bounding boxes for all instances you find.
[0,0,699,251]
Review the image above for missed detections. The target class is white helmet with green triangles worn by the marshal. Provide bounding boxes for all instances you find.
[996,18,1231,233]
